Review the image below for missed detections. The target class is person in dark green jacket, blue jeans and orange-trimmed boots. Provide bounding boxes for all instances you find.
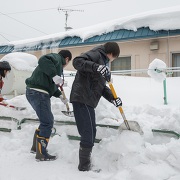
[25,50,72,161]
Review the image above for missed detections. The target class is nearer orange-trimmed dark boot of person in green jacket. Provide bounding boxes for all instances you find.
[36,135,57,161]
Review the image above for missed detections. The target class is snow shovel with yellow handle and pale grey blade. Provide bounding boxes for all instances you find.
[108,81,143,134]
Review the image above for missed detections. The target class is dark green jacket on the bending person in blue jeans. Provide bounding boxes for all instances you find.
[25,53,66,97]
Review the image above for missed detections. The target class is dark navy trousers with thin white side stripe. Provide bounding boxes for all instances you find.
[72,102,96,148]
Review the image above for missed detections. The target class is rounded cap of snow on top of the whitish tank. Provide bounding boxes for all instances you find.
[1,52,38,72]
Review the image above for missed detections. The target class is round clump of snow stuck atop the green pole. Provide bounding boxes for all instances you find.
[148,59,166,82]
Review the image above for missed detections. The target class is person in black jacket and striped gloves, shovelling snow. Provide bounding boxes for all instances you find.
[70,42,122,171]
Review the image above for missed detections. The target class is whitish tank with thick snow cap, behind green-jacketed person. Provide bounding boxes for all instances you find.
[0,52,38,96]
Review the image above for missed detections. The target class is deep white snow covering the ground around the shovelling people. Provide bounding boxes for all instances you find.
[0,75,180,180]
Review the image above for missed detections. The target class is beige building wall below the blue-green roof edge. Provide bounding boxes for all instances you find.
[0,36,180,76]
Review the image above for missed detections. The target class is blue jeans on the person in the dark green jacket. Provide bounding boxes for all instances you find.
[26,88,54,138]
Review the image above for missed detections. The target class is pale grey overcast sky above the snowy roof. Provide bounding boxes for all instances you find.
[0,0,180,43]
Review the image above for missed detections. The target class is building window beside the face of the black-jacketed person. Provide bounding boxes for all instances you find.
[111,56,131,71]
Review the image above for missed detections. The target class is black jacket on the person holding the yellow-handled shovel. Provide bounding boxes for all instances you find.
[70,46,109,108]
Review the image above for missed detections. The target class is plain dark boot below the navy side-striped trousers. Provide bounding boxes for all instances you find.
[78,147,92,171]
